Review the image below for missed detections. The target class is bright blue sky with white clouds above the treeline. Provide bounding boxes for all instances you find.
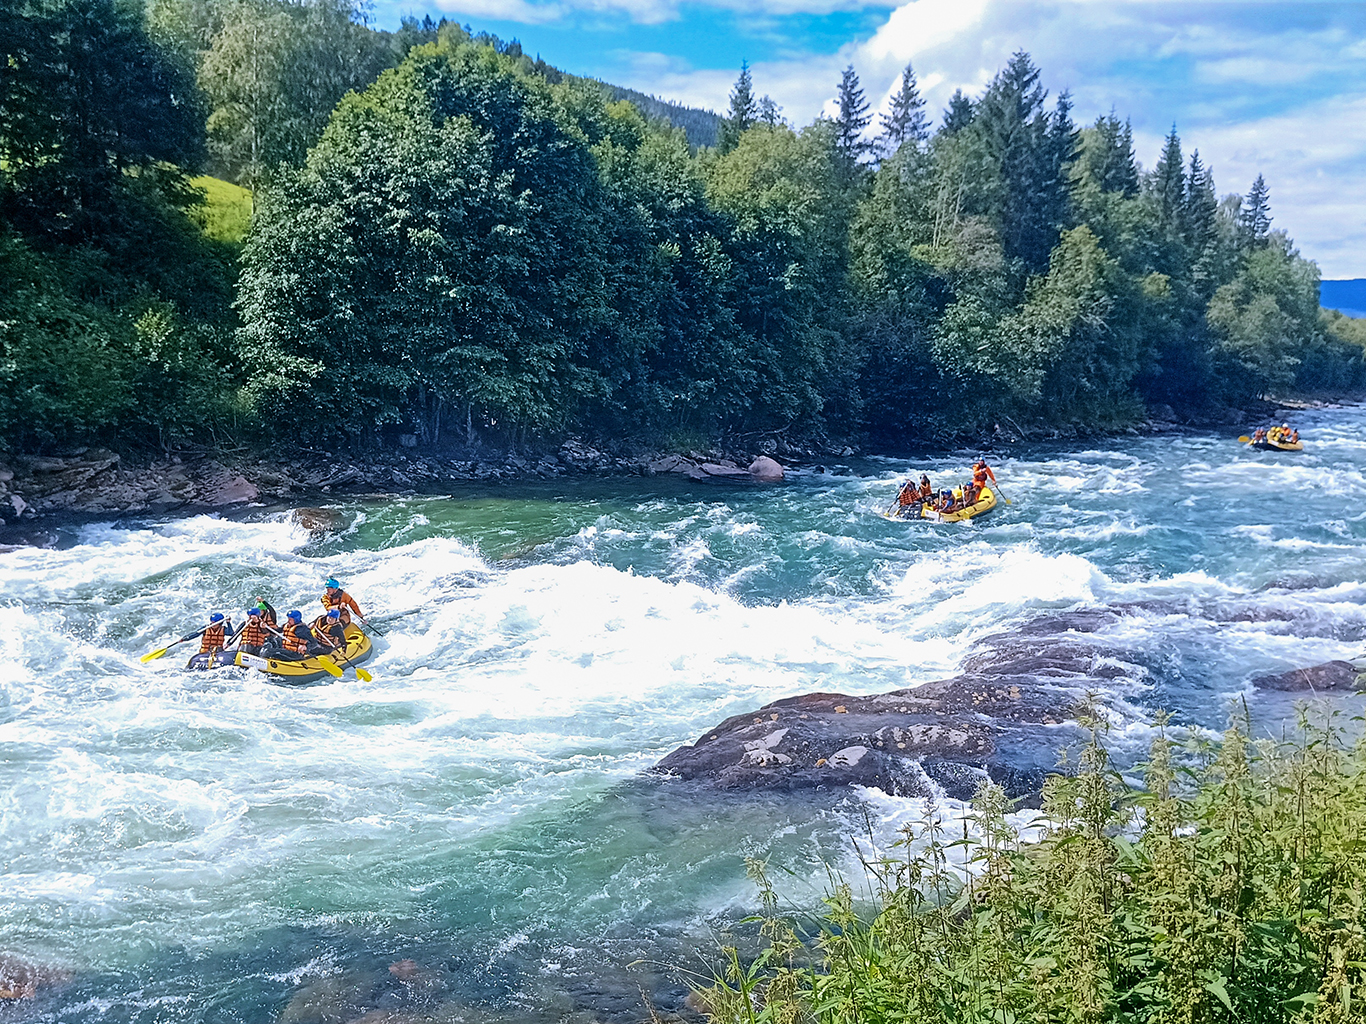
[372,0,1366,277]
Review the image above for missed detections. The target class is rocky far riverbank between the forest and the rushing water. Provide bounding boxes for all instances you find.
[0,400,1344,539]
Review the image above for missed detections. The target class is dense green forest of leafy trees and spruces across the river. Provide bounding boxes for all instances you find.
[0,0,1366,452]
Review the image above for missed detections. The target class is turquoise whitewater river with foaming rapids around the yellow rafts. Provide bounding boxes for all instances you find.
[0,407,1366,1024]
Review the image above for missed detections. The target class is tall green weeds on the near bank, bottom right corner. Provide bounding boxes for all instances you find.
[701,711,1366,1024]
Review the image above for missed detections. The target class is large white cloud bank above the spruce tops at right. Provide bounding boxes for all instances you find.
[623,0,1366,277]
